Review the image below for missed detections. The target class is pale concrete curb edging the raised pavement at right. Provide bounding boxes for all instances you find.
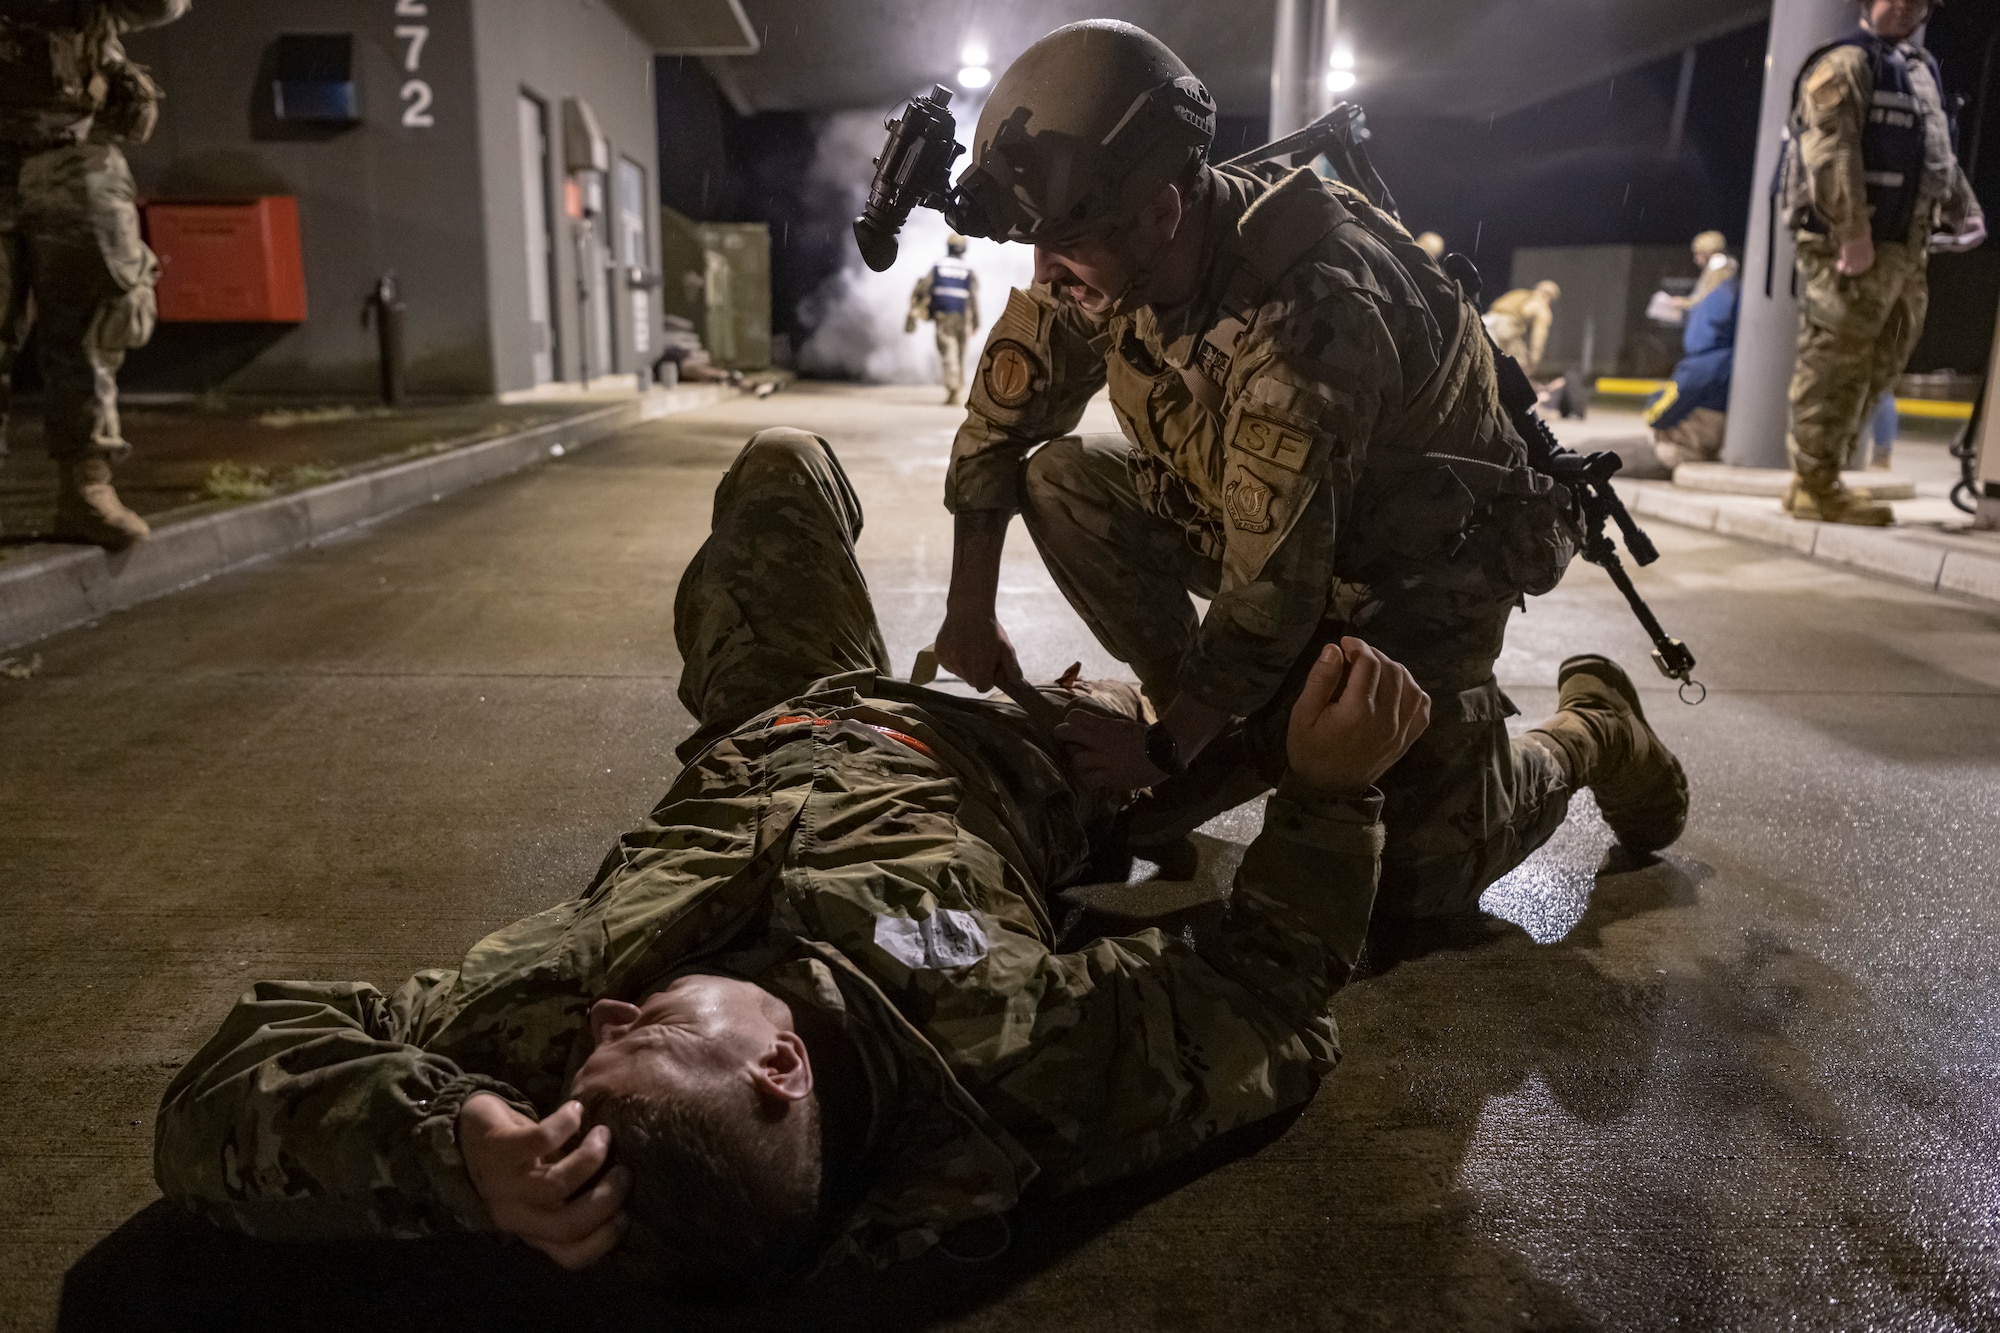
[1618,472,2000,604]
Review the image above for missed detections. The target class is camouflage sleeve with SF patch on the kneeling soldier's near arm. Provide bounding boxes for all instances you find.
[1180,284,1400,715]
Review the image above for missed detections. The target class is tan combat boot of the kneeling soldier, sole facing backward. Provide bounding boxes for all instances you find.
[1528,652,1688,853]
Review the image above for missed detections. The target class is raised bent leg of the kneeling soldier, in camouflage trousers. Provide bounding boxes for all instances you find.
[1022,434,1218,709]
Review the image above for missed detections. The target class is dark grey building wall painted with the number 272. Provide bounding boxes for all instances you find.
[126,0,492,394]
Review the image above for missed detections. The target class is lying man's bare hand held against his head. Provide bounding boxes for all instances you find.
[458,1093,632,1269]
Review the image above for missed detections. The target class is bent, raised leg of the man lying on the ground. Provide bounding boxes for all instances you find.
[674,426,890,759]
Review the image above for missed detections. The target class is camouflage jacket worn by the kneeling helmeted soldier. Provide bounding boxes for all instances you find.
[946,170,1552,719]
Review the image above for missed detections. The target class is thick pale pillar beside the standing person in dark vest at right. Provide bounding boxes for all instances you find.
[1722,0,1860,468]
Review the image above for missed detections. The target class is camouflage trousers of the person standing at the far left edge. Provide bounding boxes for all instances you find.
[0,144,160,458]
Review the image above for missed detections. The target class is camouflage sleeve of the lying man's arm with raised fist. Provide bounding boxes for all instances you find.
[964,783,1382,1191]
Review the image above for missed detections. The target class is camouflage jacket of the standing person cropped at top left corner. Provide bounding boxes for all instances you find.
[0,0,192,146]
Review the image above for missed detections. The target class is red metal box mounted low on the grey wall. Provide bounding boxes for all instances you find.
[144,194,306,324]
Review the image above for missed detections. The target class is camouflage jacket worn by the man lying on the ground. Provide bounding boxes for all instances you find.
[154,673,1382,1269]
